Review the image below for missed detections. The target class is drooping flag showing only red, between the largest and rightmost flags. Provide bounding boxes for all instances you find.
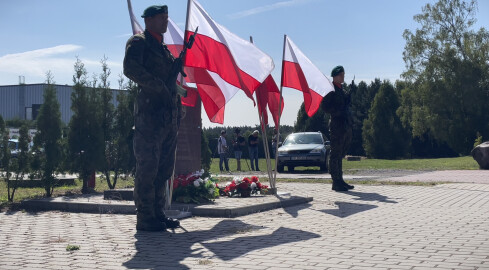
[256,75,284,127]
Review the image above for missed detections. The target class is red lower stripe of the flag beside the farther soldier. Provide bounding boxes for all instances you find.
[282,61,323,117]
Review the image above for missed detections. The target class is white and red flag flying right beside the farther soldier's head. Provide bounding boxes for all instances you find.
[282,36,334,117]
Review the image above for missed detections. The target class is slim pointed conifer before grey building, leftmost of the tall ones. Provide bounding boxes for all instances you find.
[34,72,64,197]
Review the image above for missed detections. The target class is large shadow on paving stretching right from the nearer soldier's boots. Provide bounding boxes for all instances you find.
[123,220,320,269]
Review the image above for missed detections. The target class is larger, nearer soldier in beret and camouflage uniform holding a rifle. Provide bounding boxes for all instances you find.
[124,5,182,231]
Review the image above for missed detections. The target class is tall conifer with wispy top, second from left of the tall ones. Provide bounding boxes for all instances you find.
[68,58,104,193]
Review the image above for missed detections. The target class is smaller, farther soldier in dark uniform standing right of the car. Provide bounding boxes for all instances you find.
[321,66,354,191]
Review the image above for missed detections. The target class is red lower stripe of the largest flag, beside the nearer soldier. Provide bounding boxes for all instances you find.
[185,31,260,99]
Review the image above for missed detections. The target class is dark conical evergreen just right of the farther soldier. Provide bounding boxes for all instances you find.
[363,81,410,159]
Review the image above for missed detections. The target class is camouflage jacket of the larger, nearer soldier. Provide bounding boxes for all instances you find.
[124,30,178,111]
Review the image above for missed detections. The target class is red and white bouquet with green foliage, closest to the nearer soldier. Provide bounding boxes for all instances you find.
[172,170,219,204]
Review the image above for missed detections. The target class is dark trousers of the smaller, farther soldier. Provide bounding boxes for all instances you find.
[329,121,353,183]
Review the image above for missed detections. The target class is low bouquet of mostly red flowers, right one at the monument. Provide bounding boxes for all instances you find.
[221,176,268,197]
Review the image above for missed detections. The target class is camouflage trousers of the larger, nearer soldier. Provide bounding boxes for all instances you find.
[134,106,177,217]
